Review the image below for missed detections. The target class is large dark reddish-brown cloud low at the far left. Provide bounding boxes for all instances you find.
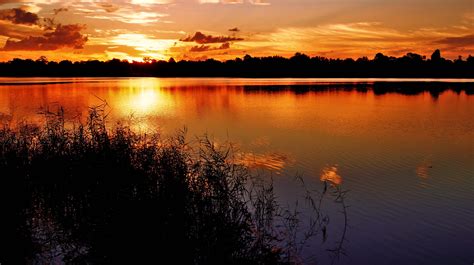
[3,24,87,51]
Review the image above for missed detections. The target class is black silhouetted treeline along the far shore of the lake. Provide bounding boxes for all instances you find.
[0,50,474,78]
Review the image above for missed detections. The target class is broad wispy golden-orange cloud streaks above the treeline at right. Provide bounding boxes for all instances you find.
[244,21,474,58]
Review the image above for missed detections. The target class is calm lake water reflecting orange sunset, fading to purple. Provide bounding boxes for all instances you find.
[0,78,474,264]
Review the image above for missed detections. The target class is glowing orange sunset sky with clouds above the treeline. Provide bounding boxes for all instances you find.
[0,0,474,61]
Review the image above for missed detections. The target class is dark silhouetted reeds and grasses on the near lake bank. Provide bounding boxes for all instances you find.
[0,108,347,264]
